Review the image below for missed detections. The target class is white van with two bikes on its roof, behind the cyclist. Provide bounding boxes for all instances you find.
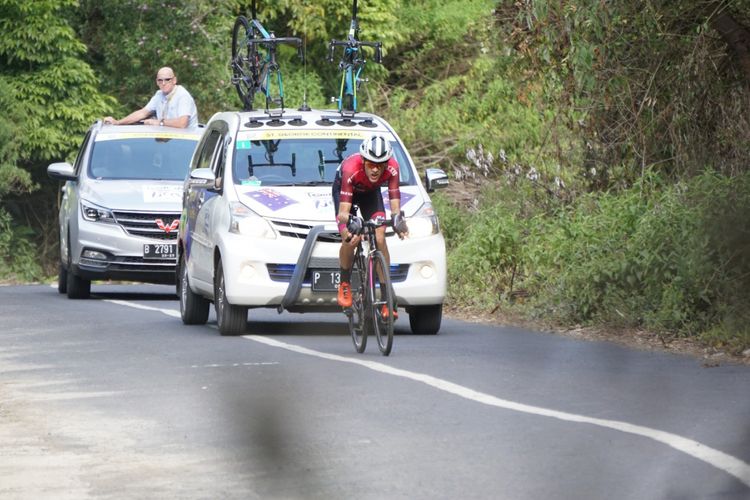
[177,110,448,335]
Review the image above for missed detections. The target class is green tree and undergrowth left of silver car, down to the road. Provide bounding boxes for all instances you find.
[0,0,114,279]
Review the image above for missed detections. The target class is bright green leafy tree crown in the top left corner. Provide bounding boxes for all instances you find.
[0,0,113,162]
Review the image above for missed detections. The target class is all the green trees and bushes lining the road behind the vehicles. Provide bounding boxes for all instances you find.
[0,0,750,353]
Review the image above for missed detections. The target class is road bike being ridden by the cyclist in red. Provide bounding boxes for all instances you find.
[344,211,395,356]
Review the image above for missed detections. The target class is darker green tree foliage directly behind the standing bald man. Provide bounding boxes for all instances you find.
[75,0,244,118]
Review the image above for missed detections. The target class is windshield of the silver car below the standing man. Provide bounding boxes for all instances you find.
[89,137,198,180]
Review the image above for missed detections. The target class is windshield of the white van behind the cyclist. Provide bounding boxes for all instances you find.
[233,139,416,186]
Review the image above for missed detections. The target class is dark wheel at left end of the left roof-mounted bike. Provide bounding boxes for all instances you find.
[230,16,259,110]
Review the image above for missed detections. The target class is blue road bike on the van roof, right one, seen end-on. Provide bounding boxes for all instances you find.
[328,0,383,113]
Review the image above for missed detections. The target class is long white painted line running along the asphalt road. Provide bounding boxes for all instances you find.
[107,300,750,487]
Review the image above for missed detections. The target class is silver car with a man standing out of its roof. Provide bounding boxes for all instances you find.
[47,122,203,299]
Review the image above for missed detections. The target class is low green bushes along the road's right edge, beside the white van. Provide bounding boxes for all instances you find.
[446,168,750,350]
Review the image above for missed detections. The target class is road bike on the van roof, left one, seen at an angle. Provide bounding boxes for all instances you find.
[235,0,303,111]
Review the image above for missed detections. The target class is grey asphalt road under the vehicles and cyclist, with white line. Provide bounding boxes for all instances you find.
[0,284,750,500]
